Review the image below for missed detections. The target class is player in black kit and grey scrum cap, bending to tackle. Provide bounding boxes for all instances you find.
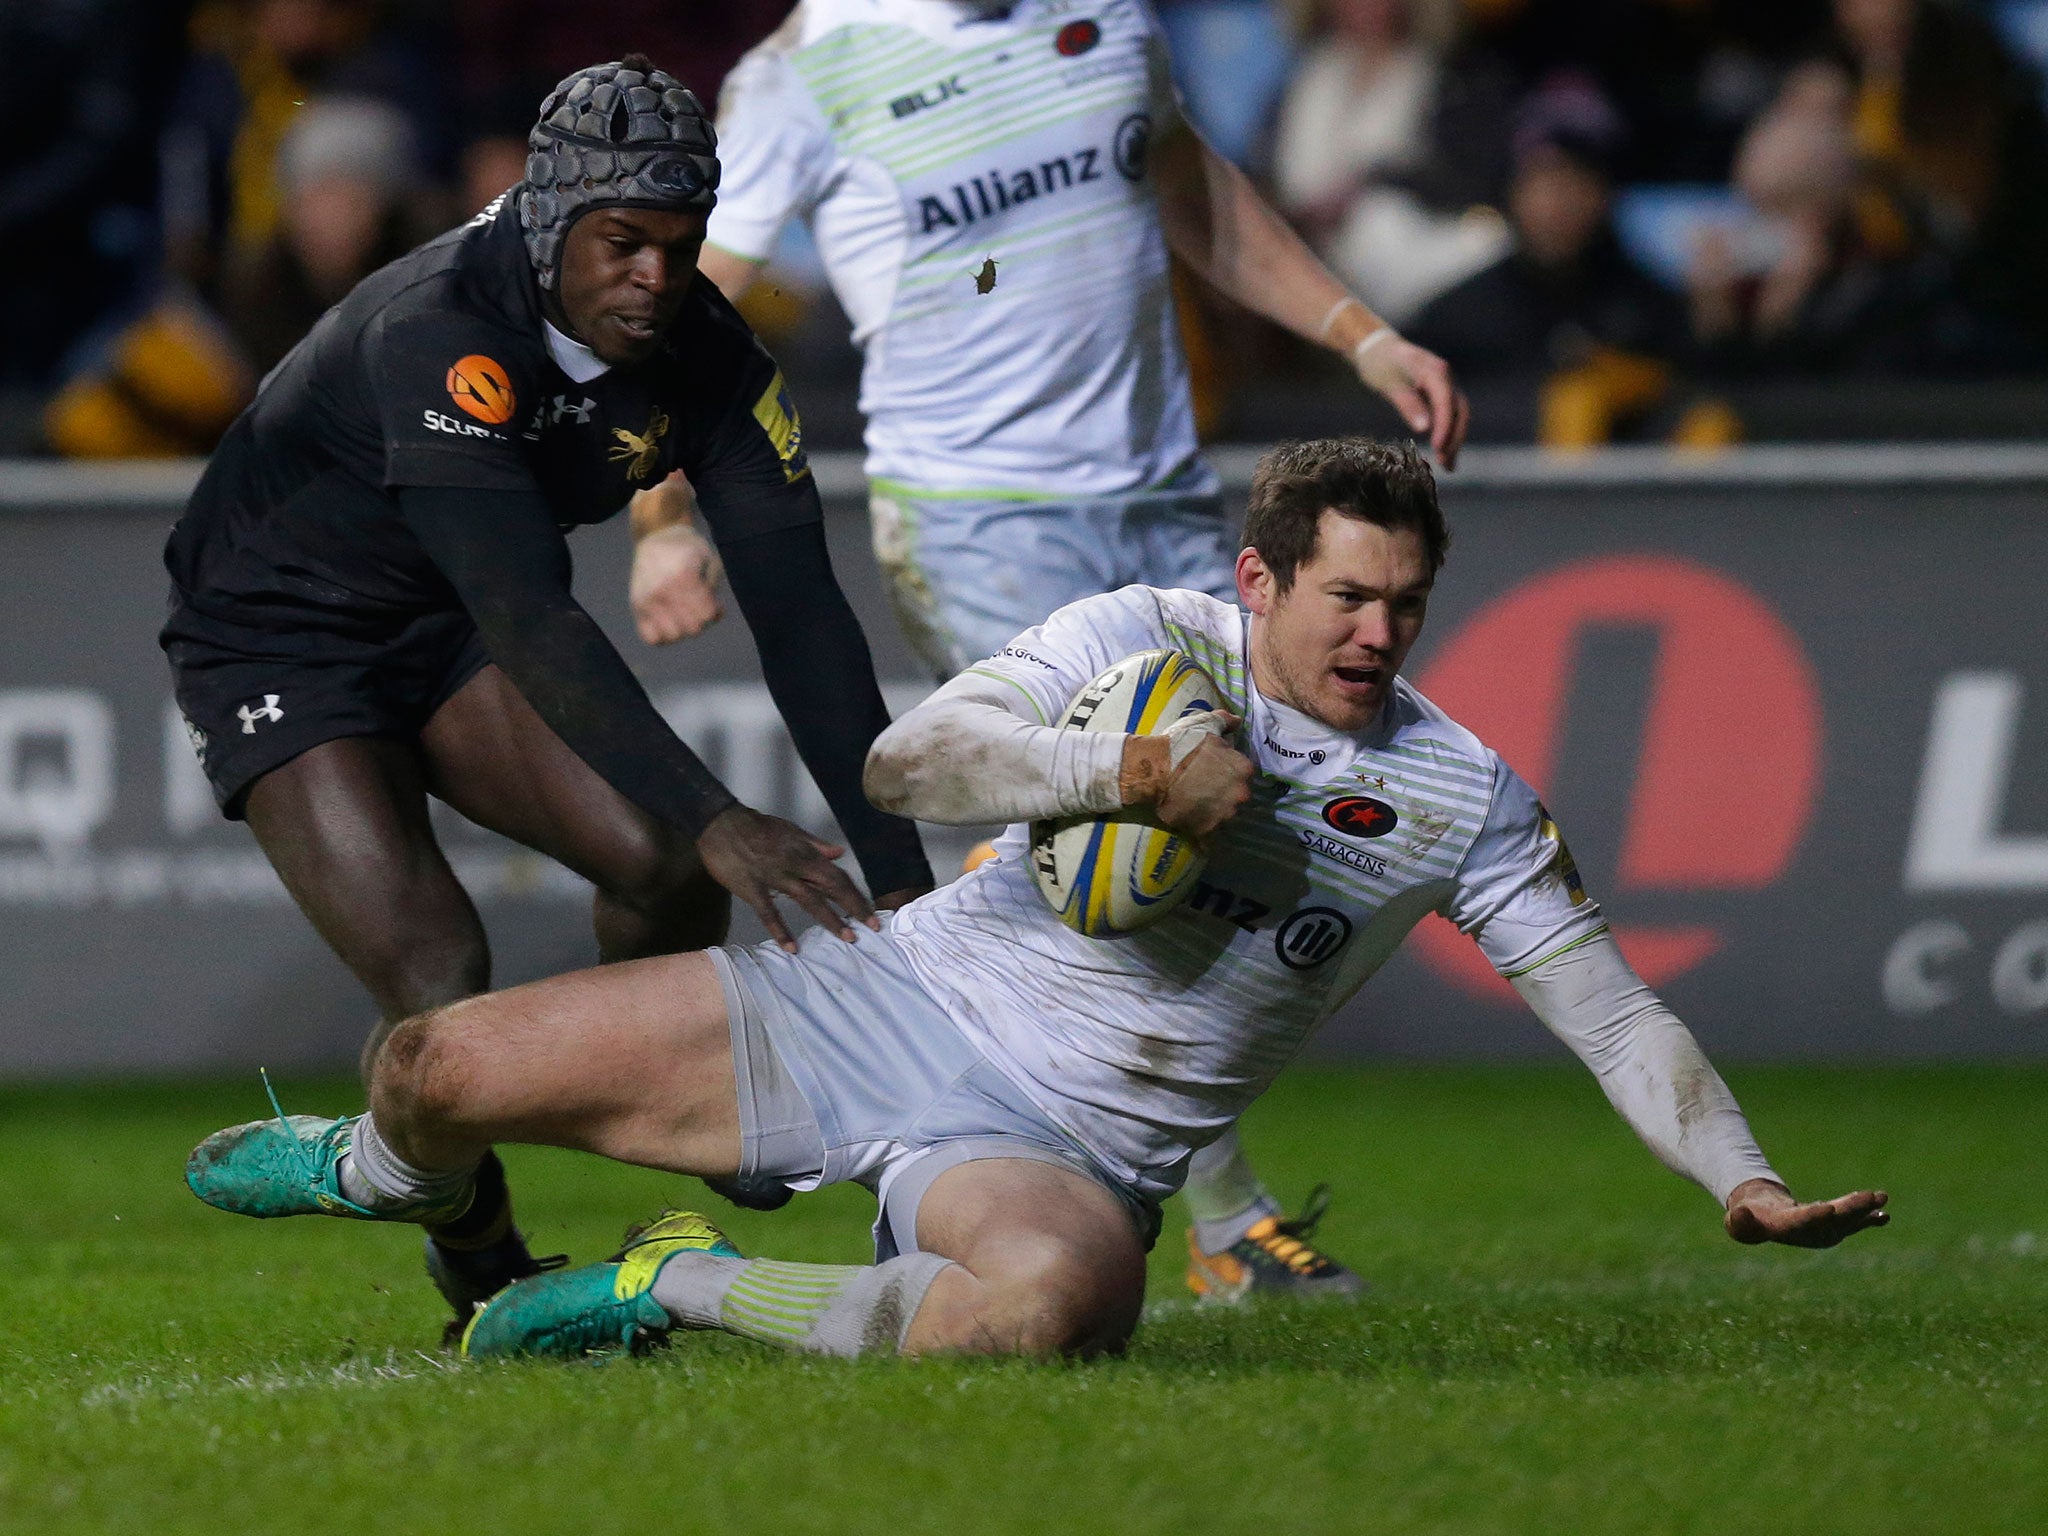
[162,55,932,1317]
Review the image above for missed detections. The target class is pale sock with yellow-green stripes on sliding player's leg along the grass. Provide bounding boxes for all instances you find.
[653,1253,952,1358]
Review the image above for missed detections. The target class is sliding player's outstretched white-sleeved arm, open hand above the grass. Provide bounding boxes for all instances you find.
[1452,766,1888,1247]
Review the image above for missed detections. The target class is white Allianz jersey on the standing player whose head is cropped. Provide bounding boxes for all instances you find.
[709,0,1214,498]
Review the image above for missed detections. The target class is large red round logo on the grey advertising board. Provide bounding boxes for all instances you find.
[1415,555,1821,1001]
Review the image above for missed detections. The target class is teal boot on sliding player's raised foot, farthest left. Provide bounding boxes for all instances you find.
[184,1075,475,1223]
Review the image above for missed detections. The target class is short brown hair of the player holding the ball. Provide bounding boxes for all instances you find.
[1245,438,1450,592]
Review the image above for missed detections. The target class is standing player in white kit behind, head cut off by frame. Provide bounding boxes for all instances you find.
[635,0,1464,1300]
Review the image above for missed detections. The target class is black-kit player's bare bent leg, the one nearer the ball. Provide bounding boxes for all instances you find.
[420,666,731,961]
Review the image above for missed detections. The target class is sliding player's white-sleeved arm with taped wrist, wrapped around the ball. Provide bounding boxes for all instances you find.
[864,588,1253,838]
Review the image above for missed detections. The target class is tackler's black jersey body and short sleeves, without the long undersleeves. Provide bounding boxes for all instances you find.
[166,197,819,627]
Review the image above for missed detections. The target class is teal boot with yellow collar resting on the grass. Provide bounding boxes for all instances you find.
[463,1210,741,1360]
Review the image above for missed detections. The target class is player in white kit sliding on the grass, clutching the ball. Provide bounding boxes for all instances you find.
[186,438,1886,1356]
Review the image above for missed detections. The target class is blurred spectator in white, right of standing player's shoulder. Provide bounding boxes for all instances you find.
[1274,0,1507,324]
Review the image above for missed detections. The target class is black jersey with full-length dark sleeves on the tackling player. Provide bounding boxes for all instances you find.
[164,195,932,893]
